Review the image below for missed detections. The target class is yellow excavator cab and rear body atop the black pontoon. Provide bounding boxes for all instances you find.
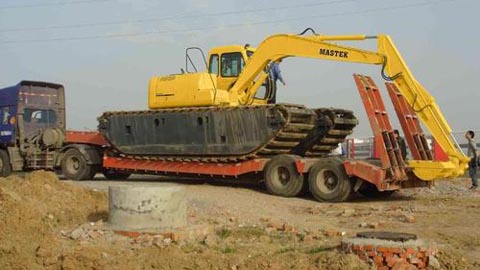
[148,44,269,109]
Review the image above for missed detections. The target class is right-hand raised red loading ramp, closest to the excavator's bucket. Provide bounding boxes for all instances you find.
[385,83,433,160]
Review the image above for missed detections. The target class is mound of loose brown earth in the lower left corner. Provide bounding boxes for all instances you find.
[0,171,107,269]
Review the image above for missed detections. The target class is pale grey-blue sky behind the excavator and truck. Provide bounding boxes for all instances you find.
[0,0,480,137]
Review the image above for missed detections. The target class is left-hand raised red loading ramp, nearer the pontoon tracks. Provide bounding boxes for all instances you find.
[353,74,408,182]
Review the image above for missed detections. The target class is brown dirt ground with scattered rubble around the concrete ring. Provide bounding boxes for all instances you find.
[0,172,480,270]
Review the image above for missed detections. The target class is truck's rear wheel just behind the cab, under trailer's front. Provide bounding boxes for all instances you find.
[61,148,97,180]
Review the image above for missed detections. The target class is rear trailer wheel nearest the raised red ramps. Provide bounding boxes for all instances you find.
[308,158,352,202]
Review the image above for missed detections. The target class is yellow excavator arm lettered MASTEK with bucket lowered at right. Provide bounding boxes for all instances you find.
[230,34,469,180]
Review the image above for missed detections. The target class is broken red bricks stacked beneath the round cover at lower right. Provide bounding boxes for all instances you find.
[342,242,437,270]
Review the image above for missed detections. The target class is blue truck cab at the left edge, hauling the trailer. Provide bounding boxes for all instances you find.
[0,81,65,176]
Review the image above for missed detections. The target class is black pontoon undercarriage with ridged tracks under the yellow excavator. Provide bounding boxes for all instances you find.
[98,104,356,162]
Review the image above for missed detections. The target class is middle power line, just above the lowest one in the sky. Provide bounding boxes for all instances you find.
[0,0,357,33]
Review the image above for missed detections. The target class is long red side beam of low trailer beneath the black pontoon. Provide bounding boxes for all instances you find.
[103,155,310,177]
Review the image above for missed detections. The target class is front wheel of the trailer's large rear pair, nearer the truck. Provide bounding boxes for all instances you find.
[265,155,303,197]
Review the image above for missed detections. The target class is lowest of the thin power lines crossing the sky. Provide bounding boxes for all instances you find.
[0,0,460,44]
